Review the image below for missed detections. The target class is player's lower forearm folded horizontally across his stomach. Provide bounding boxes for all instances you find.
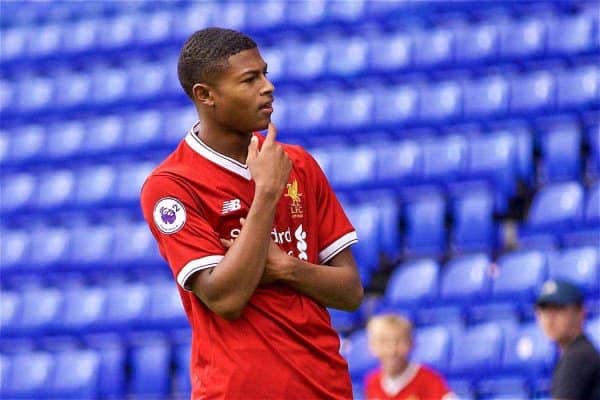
[280,257,364,311]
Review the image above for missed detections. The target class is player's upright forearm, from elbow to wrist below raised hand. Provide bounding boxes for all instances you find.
[191,193,277,319]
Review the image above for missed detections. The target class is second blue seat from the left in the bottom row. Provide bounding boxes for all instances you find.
[50,350,100,399]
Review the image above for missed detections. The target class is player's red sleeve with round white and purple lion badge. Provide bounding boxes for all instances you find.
[141,175,225,291]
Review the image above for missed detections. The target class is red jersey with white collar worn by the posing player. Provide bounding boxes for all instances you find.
[141,125,357,400]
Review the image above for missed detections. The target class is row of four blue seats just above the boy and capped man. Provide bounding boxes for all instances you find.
[379,246,600,308]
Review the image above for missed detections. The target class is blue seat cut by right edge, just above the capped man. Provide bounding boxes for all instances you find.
[548,246,600,291]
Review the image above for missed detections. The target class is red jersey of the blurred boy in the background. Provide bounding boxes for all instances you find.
[365,364,455,400]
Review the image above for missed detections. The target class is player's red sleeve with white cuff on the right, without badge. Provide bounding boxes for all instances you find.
[307,148,358,264]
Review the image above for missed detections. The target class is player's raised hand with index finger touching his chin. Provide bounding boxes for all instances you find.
[246,123,292,199]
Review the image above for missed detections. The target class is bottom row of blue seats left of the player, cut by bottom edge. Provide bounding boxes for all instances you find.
[0,329,190,400]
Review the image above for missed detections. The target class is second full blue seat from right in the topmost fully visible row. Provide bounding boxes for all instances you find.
[500,17,546,57]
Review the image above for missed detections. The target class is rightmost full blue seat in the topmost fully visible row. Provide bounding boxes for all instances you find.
[548,14,593,53]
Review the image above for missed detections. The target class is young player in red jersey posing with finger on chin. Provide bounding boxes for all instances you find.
[141,28,363,400]
